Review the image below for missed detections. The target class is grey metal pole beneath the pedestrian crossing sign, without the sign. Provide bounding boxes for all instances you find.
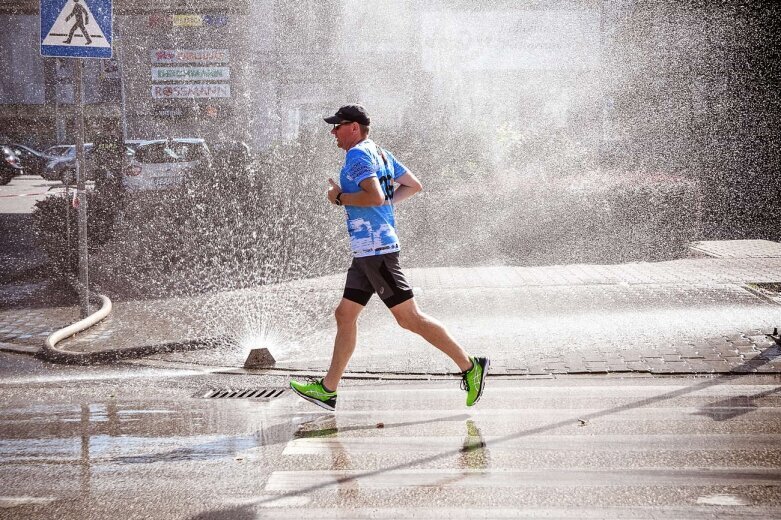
[75,60,89,318]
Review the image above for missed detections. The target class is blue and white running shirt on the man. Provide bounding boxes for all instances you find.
[339,139,407,258]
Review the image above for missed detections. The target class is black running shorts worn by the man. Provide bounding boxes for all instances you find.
[344,252,413,309]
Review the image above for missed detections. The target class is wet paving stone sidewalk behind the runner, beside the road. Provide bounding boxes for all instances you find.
[0,252,781,375]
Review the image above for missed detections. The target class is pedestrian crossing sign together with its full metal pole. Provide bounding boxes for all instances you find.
[41,0,113,318]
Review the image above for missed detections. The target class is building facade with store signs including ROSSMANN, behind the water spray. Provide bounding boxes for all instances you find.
[0,0,602,153]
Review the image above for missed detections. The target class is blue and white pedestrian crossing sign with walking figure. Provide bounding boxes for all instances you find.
[41,0,112,58]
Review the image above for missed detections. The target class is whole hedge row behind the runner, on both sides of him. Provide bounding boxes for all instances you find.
[30,125,700,297]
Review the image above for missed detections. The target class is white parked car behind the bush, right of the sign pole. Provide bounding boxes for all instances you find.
[122,138,212,192]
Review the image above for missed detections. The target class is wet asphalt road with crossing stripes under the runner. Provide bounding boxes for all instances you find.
[0,354,781,519]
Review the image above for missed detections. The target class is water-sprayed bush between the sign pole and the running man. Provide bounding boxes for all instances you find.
[90,132,349,296]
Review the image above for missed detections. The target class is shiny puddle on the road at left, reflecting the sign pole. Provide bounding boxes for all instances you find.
[0,401,296,465]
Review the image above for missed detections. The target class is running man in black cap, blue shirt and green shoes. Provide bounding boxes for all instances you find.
[290,105,489,411]
